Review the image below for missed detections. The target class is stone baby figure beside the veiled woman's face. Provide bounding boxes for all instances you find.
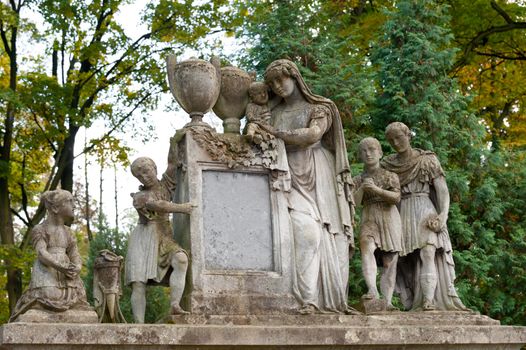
[246,81,270,144]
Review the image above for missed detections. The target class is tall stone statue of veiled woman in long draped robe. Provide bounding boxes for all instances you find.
[260,60,353,314]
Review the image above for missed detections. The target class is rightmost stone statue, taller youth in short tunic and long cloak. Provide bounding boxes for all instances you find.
[382,122,467,311]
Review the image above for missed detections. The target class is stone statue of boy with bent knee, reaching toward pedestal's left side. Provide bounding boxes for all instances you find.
[125,139,193,323]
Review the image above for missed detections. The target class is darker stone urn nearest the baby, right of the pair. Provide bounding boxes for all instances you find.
[213,66,254,134]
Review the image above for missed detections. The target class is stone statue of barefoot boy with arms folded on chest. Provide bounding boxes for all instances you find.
[353,137,402,310]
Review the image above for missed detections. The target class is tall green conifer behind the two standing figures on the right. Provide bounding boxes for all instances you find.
[373,0,526,323]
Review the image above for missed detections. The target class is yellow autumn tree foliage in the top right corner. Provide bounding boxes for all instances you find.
[450,0,526,150]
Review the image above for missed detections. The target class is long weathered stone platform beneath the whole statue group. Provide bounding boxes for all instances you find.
[0,312,526,350]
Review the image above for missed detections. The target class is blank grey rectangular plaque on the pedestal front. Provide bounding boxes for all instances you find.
[202,170,274,271]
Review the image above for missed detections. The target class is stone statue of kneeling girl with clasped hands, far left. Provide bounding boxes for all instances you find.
[10,190,97,323]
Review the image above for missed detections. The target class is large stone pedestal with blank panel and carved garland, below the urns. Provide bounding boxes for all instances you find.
[174,129,298,315]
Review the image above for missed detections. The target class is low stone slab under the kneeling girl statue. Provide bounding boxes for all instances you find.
[10,309,99,323]
